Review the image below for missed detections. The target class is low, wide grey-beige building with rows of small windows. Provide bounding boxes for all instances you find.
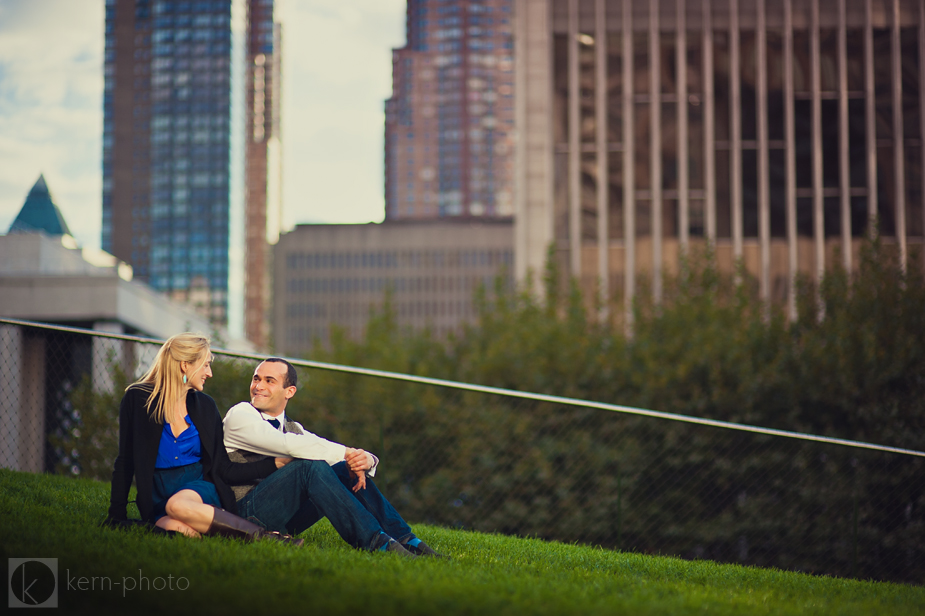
[273,219,513,356]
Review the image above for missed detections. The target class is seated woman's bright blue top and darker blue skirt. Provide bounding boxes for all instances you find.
[153,415,222,521]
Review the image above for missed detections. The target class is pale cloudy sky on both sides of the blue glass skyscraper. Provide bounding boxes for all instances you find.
[0,0,405,247]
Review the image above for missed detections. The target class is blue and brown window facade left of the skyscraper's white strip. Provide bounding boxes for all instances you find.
[102,0,232,323]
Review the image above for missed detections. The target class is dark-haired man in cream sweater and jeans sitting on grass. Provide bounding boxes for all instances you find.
[224,357,441,556]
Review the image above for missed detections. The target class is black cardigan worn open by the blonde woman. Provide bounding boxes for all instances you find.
[109,384,276,522]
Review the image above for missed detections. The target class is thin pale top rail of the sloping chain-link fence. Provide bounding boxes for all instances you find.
[0,319,925,458]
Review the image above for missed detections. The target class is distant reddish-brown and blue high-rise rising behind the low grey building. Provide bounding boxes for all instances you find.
[385,0,514,220]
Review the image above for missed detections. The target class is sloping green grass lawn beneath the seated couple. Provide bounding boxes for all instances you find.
[0,469,925,616]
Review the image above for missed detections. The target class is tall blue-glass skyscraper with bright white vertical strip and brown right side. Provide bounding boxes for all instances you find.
[102,0,278,334]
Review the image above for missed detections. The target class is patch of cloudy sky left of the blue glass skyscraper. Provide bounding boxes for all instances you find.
[0,0,104,246]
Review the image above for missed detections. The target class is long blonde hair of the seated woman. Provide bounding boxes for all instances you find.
[129,332,212,424]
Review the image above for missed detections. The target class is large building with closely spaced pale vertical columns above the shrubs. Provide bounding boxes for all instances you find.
[514,0,925,322]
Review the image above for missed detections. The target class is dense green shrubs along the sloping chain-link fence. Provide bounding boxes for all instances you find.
[65,239,925,581]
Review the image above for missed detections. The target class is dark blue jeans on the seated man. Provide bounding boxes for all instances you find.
[238,460,411,550]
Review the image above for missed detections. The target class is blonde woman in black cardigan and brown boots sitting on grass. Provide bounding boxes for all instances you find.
[108,333,302,545]
